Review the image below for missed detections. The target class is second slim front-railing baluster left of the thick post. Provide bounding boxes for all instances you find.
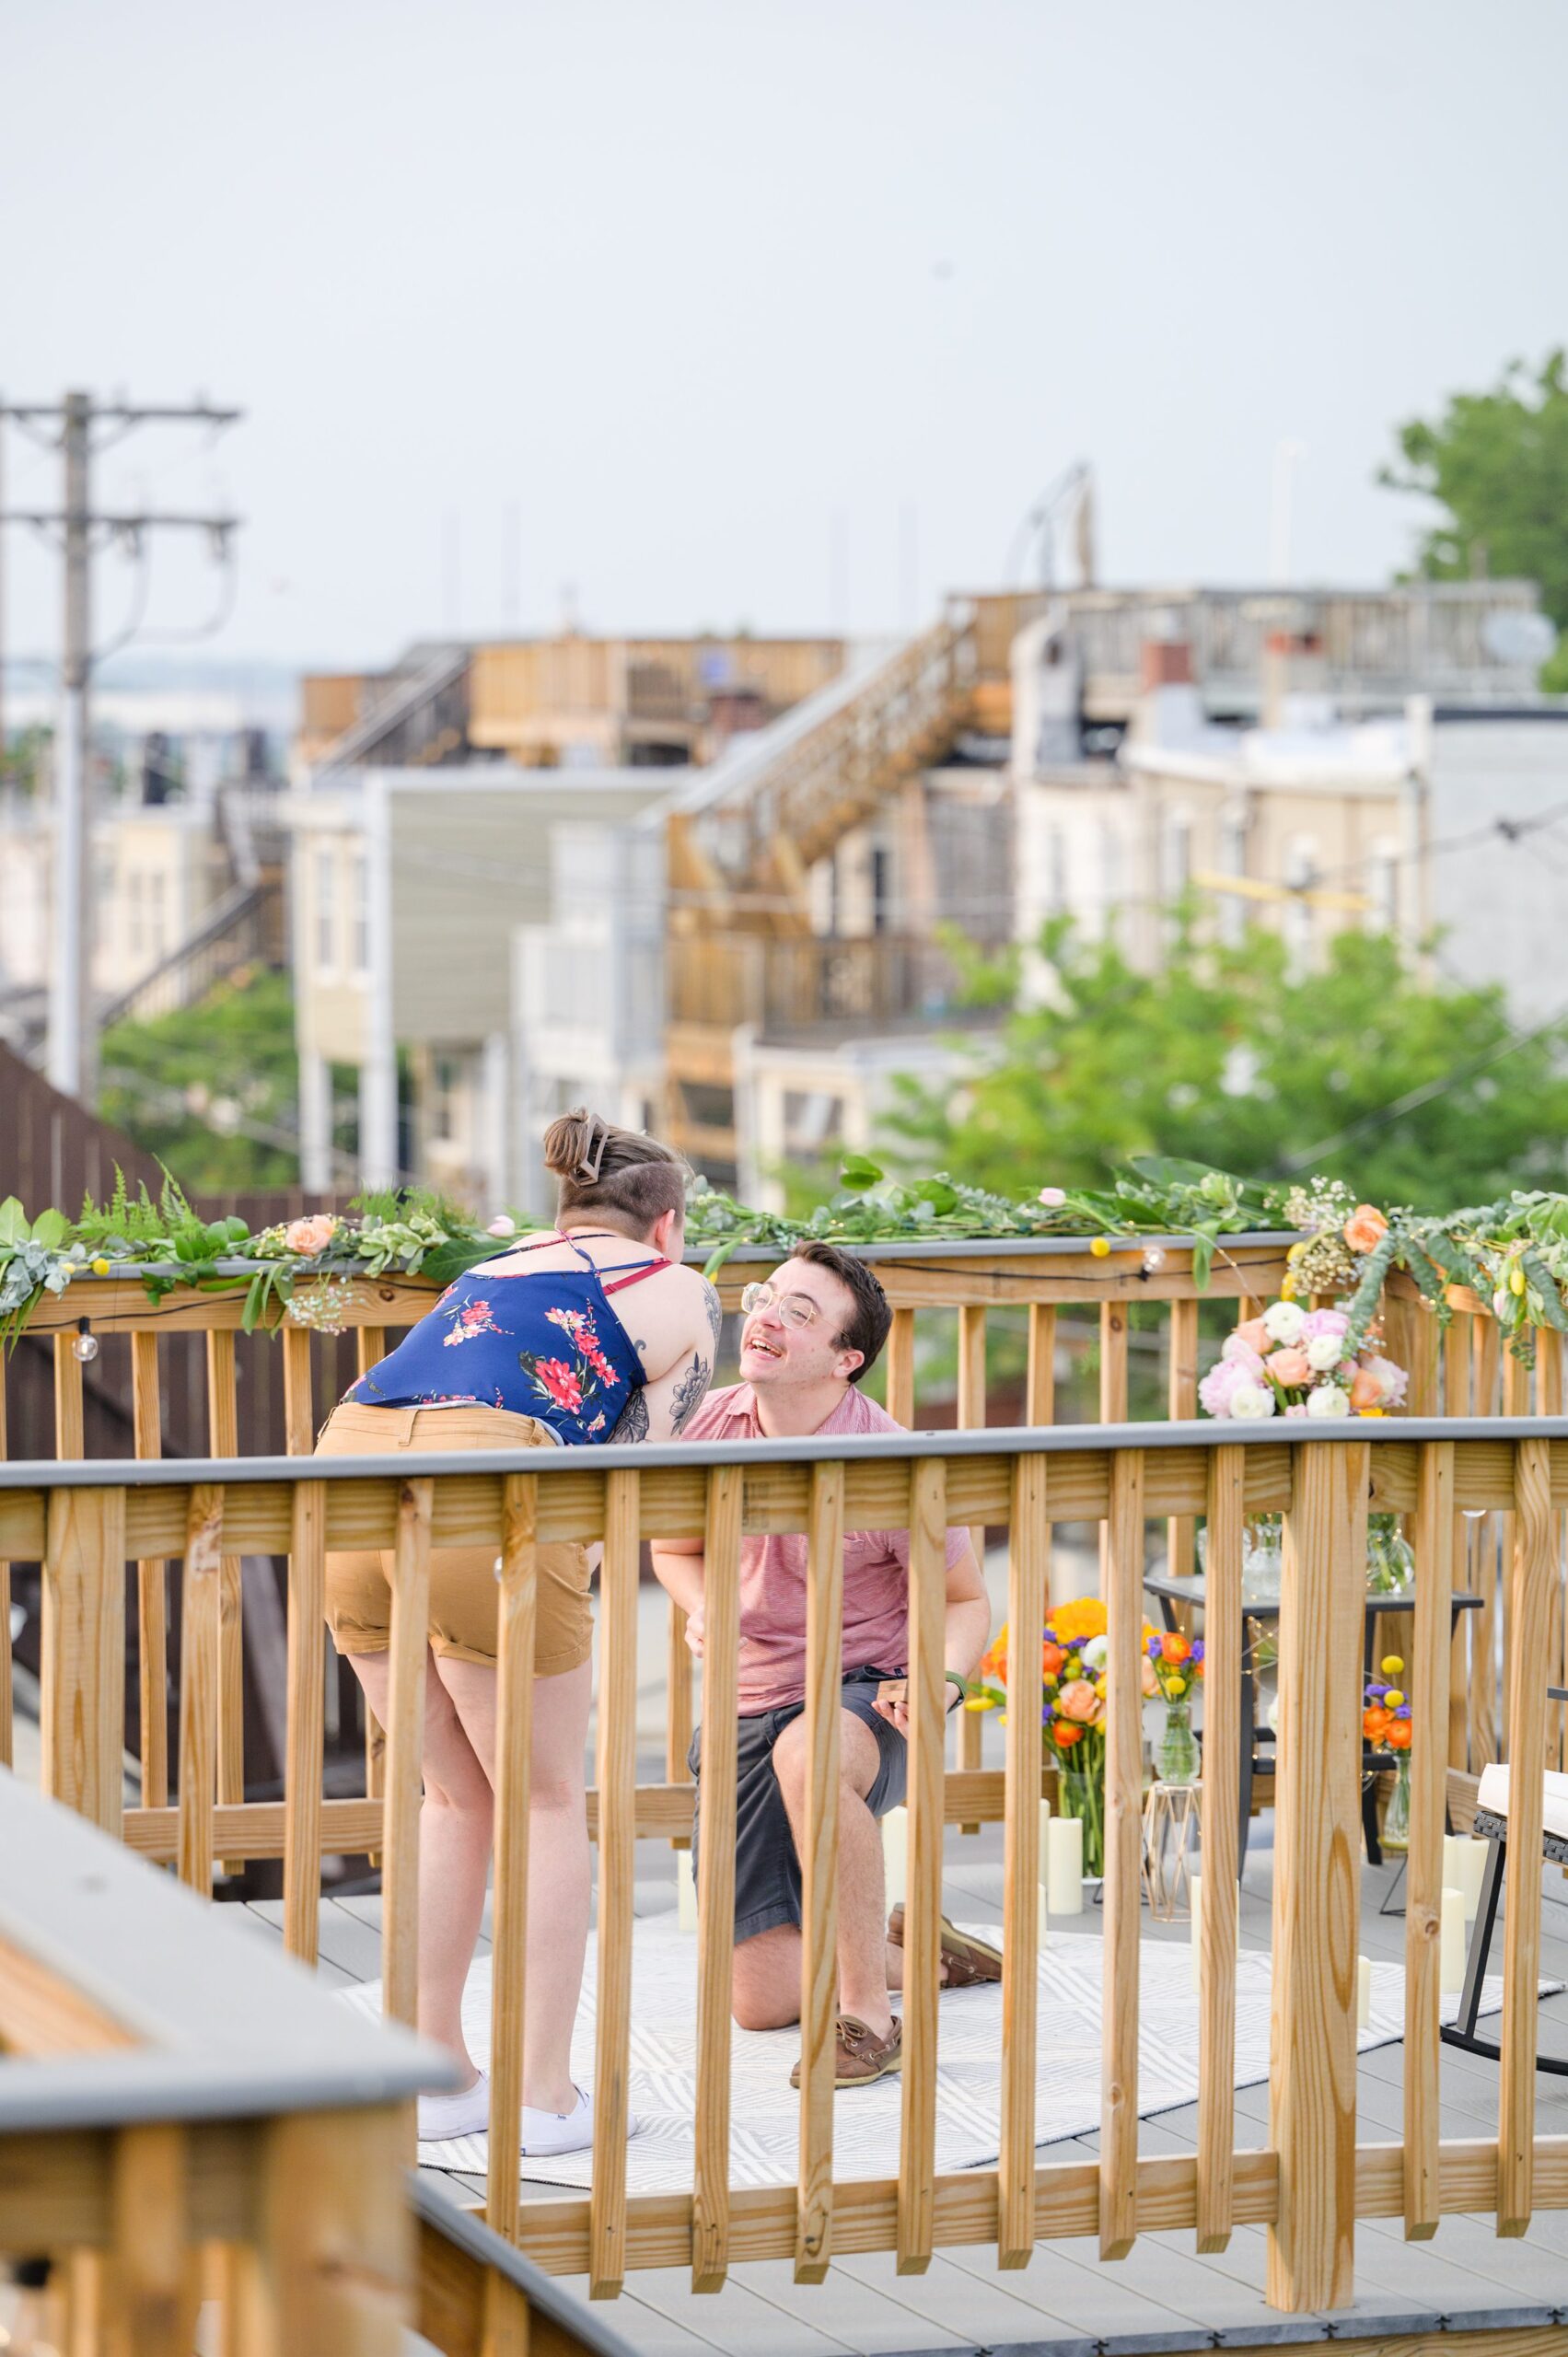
[1098,1449,1144,2258]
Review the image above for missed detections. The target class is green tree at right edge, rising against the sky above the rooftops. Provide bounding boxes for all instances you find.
[1379,351,1568,686]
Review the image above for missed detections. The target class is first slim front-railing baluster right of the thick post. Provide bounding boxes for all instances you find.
[1403,1442,1455,2242]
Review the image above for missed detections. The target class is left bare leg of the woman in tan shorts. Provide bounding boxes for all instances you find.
[349,1653,495,2086]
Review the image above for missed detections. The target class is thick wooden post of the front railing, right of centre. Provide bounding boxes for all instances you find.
[1269,1440,1370,2310]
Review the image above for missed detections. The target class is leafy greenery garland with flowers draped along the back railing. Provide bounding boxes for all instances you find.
[0,1155,1568,1360]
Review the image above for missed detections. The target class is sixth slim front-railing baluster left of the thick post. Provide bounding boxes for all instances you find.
[691,1466,745,2291]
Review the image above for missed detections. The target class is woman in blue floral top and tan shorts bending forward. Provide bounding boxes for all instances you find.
[316,1112,719,2154]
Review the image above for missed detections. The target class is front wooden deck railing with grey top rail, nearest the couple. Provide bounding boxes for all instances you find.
[0,1404,1568,2310]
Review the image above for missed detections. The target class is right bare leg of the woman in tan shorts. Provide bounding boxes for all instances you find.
[436,1657,594,2112]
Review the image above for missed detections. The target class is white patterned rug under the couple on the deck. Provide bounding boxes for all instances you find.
[344,1914,1527,2194]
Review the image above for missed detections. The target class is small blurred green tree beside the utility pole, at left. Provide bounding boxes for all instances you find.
[99,971,299,1195]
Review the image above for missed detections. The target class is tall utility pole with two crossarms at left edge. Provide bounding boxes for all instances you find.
[0,394,240,1108]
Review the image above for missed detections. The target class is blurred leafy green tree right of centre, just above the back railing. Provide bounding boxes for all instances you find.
[896,919,1568,1209]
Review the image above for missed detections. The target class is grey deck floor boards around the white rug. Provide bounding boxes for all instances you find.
[245,1819,1568,2357]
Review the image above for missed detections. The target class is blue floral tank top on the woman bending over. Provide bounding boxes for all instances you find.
[344,1230,669,1447]
